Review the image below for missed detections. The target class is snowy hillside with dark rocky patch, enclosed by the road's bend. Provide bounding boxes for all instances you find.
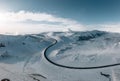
[49,31,120,67]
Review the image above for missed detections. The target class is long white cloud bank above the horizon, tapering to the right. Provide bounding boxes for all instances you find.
[0,11,85,33]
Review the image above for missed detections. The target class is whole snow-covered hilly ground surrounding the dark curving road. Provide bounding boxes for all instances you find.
[0,30,120,81]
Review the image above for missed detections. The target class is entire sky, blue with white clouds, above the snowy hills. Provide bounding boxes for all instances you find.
[0,0,120,33]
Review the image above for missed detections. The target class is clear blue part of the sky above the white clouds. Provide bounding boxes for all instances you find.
[0,0,120,24]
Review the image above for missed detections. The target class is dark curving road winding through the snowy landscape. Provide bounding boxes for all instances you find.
[44,39,120,69]
